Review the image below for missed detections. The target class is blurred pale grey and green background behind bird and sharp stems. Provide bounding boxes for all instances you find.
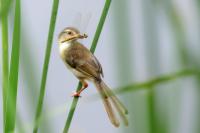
[0,0,200,133]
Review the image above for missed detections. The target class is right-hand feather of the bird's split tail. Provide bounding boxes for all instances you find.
[95,81,128,126]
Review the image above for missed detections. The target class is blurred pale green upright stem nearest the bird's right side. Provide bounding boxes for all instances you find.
[113,0,134,84]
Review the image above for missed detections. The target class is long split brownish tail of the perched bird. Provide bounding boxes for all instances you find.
[94,80,128,127]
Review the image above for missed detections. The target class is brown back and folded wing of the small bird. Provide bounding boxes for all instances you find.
[65,43,103,78]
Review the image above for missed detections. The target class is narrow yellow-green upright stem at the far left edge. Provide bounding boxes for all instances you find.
[0,0,9,133]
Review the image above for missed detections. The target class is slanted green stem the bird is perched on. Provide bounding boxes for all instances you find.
[63,0,111,133]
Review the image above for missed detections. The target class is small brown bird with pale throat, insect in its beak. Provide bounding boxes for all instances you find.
[58,27,128,127]
